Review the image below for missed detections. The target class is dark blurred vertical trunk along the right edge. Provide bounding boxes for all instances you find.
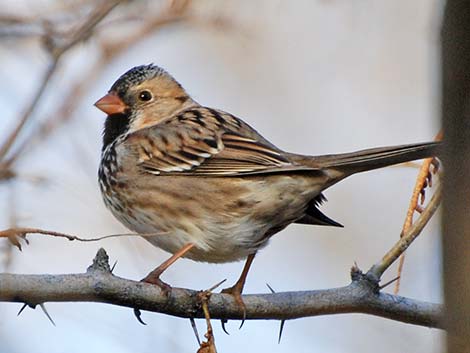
[441,0,470,353]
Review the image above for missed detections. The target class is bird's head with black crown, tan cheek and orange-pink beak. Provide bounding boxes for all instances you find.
[95,64,194,148]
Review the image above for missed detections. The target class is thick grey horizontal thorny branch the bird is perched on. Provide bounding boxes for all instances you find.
[0,249,443,328]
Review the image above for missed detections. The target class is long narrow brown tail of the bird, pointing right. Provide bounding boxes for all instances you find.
[315,142,441,175]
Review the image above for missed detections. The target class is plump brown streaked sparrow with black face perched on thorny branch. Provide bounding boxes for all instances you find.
[95,64,439,315]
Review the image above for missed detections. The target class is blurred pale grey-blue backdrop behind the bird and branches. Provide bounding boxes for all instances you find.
[0,0,443,353]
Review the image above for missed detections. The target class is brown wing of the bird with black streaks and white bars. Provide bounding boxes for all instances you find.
[124,107,314,176]
